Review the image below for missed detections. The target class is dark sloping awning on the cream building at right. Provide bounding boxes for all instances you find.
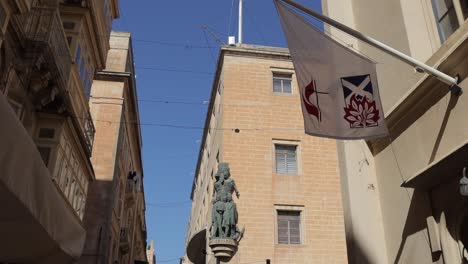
[401,141,468,189]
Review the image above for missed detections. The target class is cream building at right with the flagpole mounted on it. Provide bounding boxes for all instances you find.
[322,0,468,264]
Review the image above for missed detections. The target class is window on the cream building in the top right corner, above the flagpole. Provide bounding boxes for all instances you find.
[432,0,464,42]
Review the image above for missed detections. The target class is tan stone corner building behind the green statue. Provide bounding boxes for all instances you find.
[182,44,347,264]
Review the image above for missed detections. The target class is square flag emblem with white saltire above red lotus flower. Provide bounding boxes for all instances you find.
[341,74,380,128]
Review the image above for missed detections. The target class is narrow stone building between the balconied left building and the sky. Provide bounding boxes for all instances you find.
[79,31,147,264]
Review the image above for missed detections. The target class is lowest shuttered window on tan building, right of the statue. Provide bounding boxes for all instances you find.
[278,211,301,244]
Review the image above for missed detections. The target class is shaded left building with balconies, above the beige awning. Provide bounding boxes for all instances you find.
[0,0,119,263]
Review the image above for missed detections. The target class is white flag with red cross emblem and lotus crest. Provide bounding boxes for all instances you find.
[275,0,388,139]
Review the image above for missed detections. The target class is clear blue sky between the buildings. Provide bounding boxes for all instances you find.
[114,0,320,264]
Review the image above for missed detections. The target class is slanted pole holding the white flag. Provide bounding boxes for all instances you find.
[276,0,461,94]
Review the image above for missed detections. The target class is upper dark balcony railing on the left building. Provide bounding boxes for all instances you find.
[24,7,71,89]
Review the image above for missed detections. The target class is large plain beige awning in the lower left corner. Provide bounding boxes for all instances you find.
[0,93,86,264]
